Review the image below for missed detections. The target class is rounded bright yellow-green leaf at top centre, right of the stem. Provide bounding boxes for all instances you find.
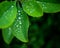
[22,1,43,17]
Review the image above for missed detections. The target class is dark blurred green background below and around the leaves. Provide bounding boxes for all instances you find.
[0,0,60,48]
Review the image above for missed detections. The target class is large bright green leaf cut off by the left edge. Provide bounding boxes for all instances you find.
[0,1,17,28]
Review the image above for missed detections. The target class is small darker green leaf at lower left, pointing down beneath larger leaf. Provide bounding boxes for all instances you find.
[2,28,14,44]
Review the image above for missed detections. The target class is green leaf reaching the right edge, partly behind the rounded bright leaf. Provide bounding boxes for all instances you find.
[37,0,60,13]
